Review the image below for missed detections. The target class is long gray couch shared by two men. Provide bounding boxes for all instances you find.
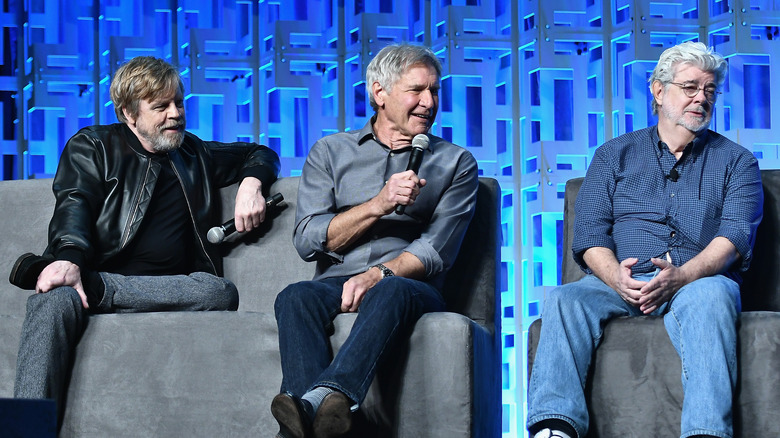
[0,177,501,438]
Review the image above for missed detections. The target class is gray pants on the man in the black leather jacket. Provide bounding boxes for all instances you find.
[14,272,238,416]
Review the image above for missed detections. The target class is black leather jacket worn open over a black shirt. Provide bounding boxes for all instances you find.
[46,123,280,275]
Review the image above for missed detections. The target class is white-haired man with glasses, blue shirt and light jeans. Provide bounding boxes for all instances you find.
[527,42,763,438]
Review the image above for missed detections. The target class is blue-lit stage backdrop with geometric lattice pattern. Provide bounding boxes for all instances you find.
[0,0,780,437]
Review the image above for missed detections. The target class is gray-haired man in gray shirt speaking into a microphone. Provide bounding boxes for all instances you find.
[271,44,478,438]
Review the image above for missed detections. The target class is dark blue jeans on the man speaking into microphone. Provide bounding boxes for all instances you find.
[274,277,444,404]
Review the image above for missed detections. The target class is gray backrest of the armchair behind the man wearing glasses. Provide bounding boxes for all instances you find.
[561,170,780,312]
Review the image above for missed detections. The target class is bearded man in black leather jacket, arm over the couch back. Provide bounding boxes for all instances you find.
[10,56,279,424]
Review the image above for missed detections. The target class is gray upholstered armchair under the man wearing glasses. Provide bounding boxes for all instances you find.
[528,170,780,438]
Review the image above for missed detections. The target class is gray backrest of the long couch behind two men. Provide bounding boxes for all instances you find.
[0,177,501,326]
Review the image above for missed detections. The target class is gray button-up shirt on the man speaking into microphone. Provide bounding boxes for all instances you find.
[293,121,478,288]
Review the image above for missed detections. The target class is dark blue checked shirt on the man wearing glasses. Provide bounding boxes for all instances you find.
[572,126,764,281]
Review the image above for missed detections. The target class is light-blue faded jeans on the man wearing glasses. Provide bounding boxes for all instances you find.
[527,274,741,438]
